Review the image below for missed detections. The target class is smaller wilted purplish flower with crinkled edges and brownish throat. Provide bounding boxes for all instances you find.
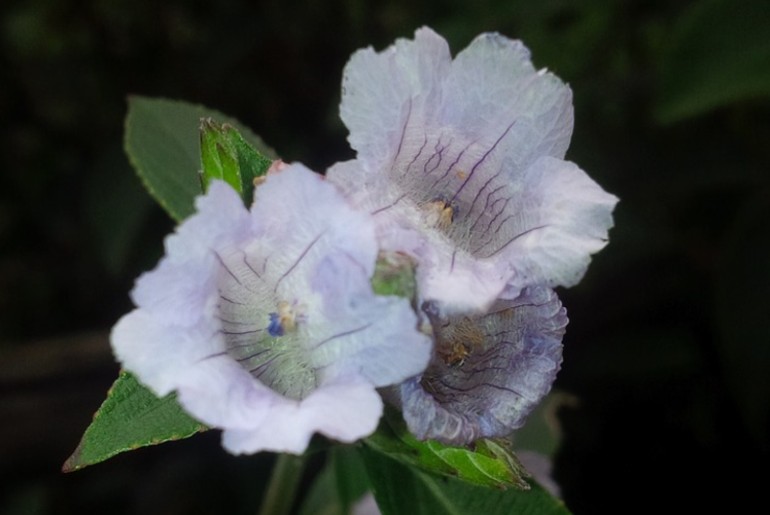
[391,286,567,445]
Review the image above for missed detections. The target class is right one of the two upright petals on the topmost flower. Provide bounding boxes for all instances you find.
[441,33,573,167]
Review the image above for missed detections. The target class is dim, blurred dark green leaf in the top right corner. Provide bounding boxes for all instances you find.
[656,0,770,122]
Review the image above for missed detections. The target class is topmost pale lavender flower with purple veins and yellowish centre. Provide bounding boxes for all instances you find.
[327,28,617,312]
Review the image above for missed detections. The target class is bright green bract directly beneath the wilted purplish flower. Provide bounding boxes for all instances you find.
[365,409,529,489]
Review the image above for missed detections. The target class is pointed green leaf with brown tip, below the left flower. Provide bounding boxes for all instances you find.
[62,372,206,472]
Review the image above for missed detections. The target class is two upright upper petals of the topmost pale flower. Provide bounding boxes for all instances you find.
[340,28,573,177]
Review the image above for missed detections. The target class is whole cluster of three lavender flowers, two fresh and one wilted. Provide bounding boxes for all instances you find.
[112,28,617,453]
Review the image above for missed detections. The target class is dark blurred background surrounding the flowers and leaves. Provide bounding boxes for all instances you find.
[0,0,770,515]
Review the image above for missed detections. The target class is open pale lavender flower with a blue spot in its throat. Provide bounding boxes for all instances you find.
[112,165,431,453]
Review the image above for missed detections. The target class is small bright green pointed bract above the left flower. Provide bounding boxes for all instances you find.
[200,118,272,205]
